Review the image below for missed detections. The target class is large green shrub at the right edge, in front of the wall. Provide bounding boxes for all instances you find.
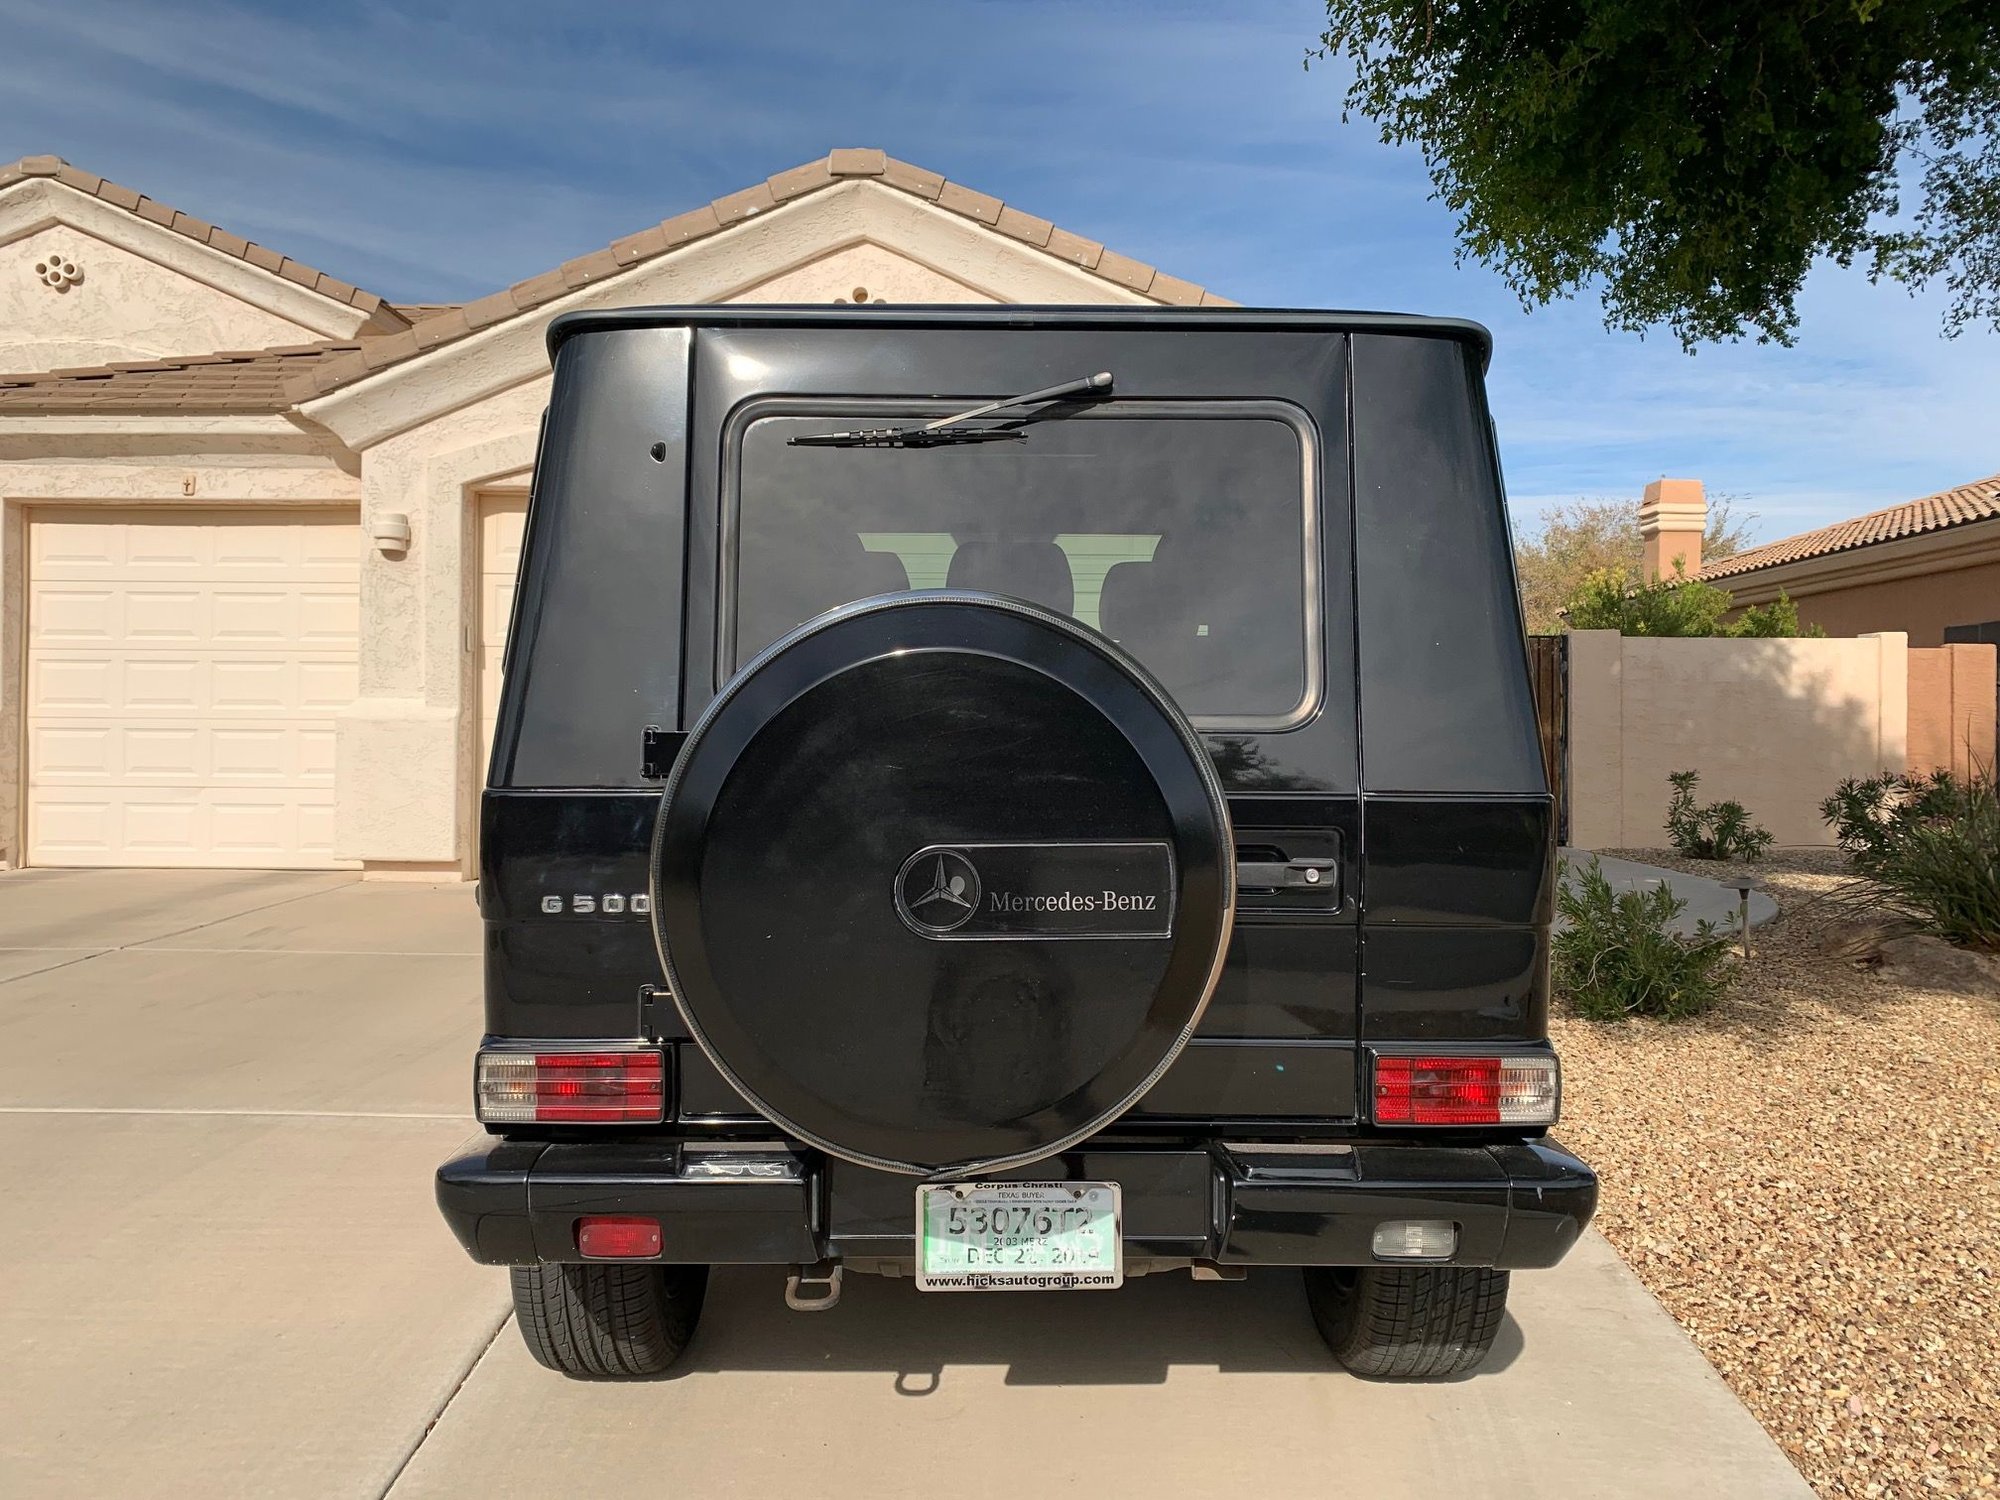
[1820,770,2000,950]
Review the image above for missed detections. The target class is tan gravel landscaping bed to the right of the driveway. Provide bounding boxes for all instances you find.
[1552,850,2000,1496]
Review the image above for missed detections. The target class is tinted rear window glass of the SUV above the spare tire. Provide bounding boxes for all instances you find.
[720,402,1318,728]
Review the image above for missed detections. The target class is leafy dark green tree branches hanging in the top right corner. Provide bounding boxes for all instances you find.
[1306,0,2000,348]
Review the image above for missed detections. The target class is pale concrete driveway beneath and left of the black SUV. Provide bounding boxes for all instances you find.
[0,870,1810,1500]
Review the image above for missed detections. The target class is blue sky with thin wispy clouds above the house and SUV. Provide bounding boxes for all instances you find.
[0,0,2000,538]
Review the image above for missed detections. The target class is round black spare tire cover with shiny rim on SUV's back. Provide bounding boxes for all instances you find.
[652,594,1236,1176]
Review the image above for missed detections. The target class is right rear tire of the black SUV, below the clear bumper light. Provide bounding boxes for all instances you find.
[1306,1266,1508,1380]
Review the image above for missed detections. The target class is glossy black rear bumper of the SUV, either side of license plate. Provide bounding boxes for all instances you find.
[438,1138,1598,1268]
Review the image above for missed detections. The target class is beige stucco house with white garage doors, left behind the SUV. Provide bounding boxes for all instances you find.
[0,150,1222,878]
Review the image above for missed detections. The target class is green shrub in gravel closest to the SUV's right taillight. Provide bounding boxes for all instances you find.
[1552,858,1734,1020]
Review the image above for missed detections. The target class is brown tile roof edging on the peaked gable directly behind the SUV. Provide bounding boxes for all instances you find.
[292,148,1236,400]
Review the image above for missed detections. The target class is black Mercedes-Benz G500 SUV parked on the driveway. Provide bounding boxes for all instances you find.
[438,306,1596,1376]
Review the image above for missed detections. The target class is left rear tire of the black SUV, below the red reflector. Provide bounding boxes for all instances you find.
[514,1264,708,1380]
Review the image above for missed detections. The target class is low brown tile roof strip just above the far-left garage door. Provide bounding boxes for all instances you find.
[0,340,362,416]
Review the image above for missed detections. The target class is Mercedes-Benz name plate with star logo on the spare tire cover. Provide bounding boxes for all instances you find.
[894,842,1174,942]
